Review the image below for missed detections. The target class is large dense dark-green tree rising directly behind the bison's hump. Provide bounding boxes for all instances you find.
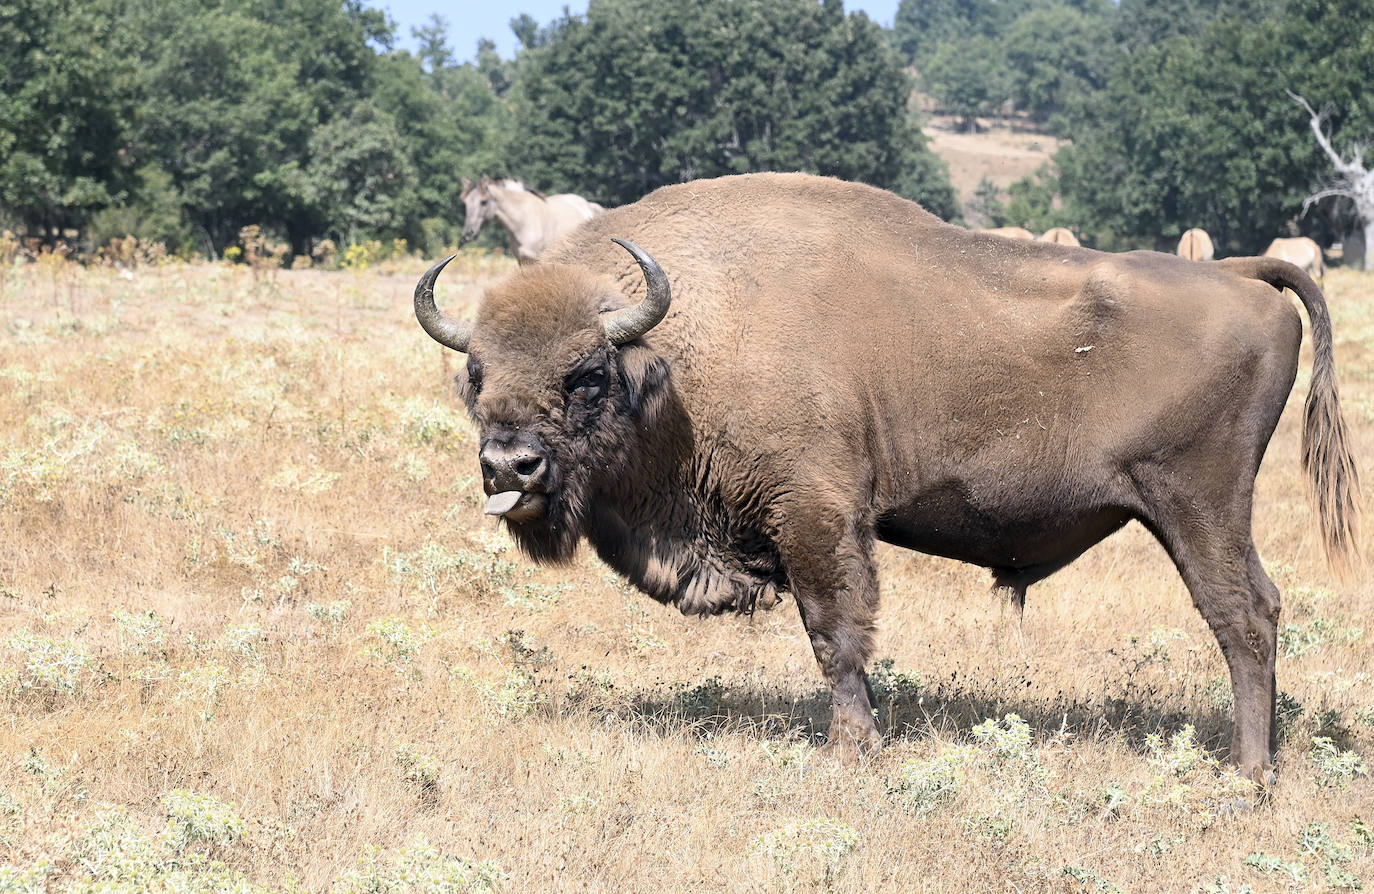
[511,0,956,217]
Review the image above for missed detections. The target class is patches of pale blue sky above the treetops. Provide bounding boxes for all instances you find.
[379,0,899,60]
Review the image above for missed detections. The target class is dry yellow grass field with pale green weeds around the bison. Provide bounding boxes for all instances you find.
[0,255,1374,893]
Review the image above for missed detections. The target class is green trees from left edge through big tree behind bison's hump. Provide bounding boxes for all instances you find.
[0,0,958,255]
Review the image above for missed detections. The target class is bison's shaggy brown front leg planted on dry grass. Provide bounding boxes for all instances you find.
[785,516,882,764]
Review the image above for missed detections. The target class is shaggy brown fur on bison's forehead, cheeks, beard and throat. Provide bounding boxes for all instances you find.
[459,265,783,614]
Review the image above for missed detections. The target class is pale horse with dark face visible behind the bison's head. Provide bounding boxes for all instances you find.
[462,177,606,264]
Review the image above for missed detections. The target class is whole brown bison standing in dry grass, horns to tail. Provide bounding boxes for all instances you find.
[415,174,1359,783]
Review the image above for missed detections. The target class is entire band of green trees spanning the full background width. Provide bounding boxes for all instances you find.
[0,0,1374,255]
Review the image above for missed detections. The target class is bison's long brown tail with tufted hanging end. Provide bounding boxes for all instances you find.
[1223,258,1362,580]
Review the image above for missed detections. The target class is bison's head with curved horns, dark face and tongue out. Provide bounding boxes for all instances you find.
[415,239,669,562]
